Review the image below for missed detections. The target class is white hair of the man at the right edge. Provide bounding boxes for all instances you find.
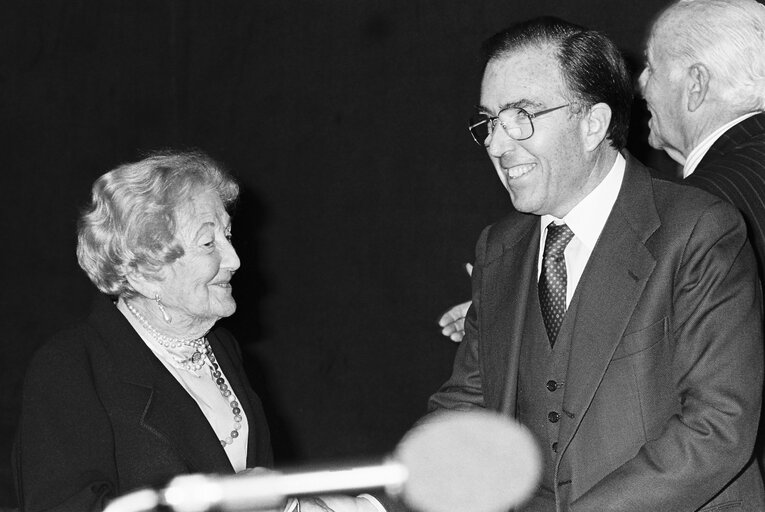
[654,0,765,114]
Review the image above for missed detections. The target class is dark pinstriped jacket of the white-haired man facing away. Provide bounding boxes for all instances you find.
[685,113,765,284]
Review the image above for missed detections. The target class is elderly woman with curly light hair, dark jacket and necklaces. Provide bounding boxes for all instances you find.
[15,153,272,511]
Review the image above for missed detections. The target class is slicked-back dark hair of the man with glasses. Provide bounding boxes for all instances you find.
[481,17,632,150]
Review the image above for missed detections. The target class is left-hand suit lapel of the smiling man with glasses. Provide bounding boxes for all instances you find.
[481,214,539,416]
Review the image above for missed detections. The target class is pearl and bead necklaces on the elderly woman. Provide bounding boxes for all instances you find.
[123,301,243,448]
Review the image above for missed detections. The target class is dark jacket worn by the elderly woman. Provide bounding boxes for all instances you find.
[14,296,272,511]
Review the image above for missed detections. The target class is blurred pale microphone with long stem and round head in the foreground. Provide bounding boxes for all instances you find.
[105,410,542,512]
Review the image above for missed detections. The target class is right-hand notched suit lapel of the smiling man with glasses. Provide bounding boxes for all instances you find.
[559,155,660,452]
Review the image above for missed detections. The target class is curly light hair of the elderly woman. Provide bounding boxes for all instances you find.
[77,152,239,297]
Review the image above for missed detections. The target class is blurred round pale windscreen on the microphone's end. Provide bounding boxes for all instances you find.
[394,411,542,512]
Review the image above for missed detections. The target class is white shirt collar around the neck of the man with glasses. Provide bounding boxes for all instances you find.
[541,154,626,250]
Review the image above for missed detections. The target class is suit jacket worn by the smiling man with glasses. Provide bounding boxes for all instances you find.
[430,156,765,512]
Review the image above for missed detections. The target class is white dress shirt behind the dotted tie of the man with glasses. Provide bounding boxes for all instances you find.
[537,155,626,307]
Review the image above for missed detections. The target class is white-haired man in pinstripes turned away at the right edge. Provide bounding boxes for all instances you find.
[640,0,765,276]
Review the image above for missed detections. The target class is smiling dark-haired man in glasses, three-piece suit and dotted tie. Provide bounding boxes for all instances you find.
[429,18,765,512]
